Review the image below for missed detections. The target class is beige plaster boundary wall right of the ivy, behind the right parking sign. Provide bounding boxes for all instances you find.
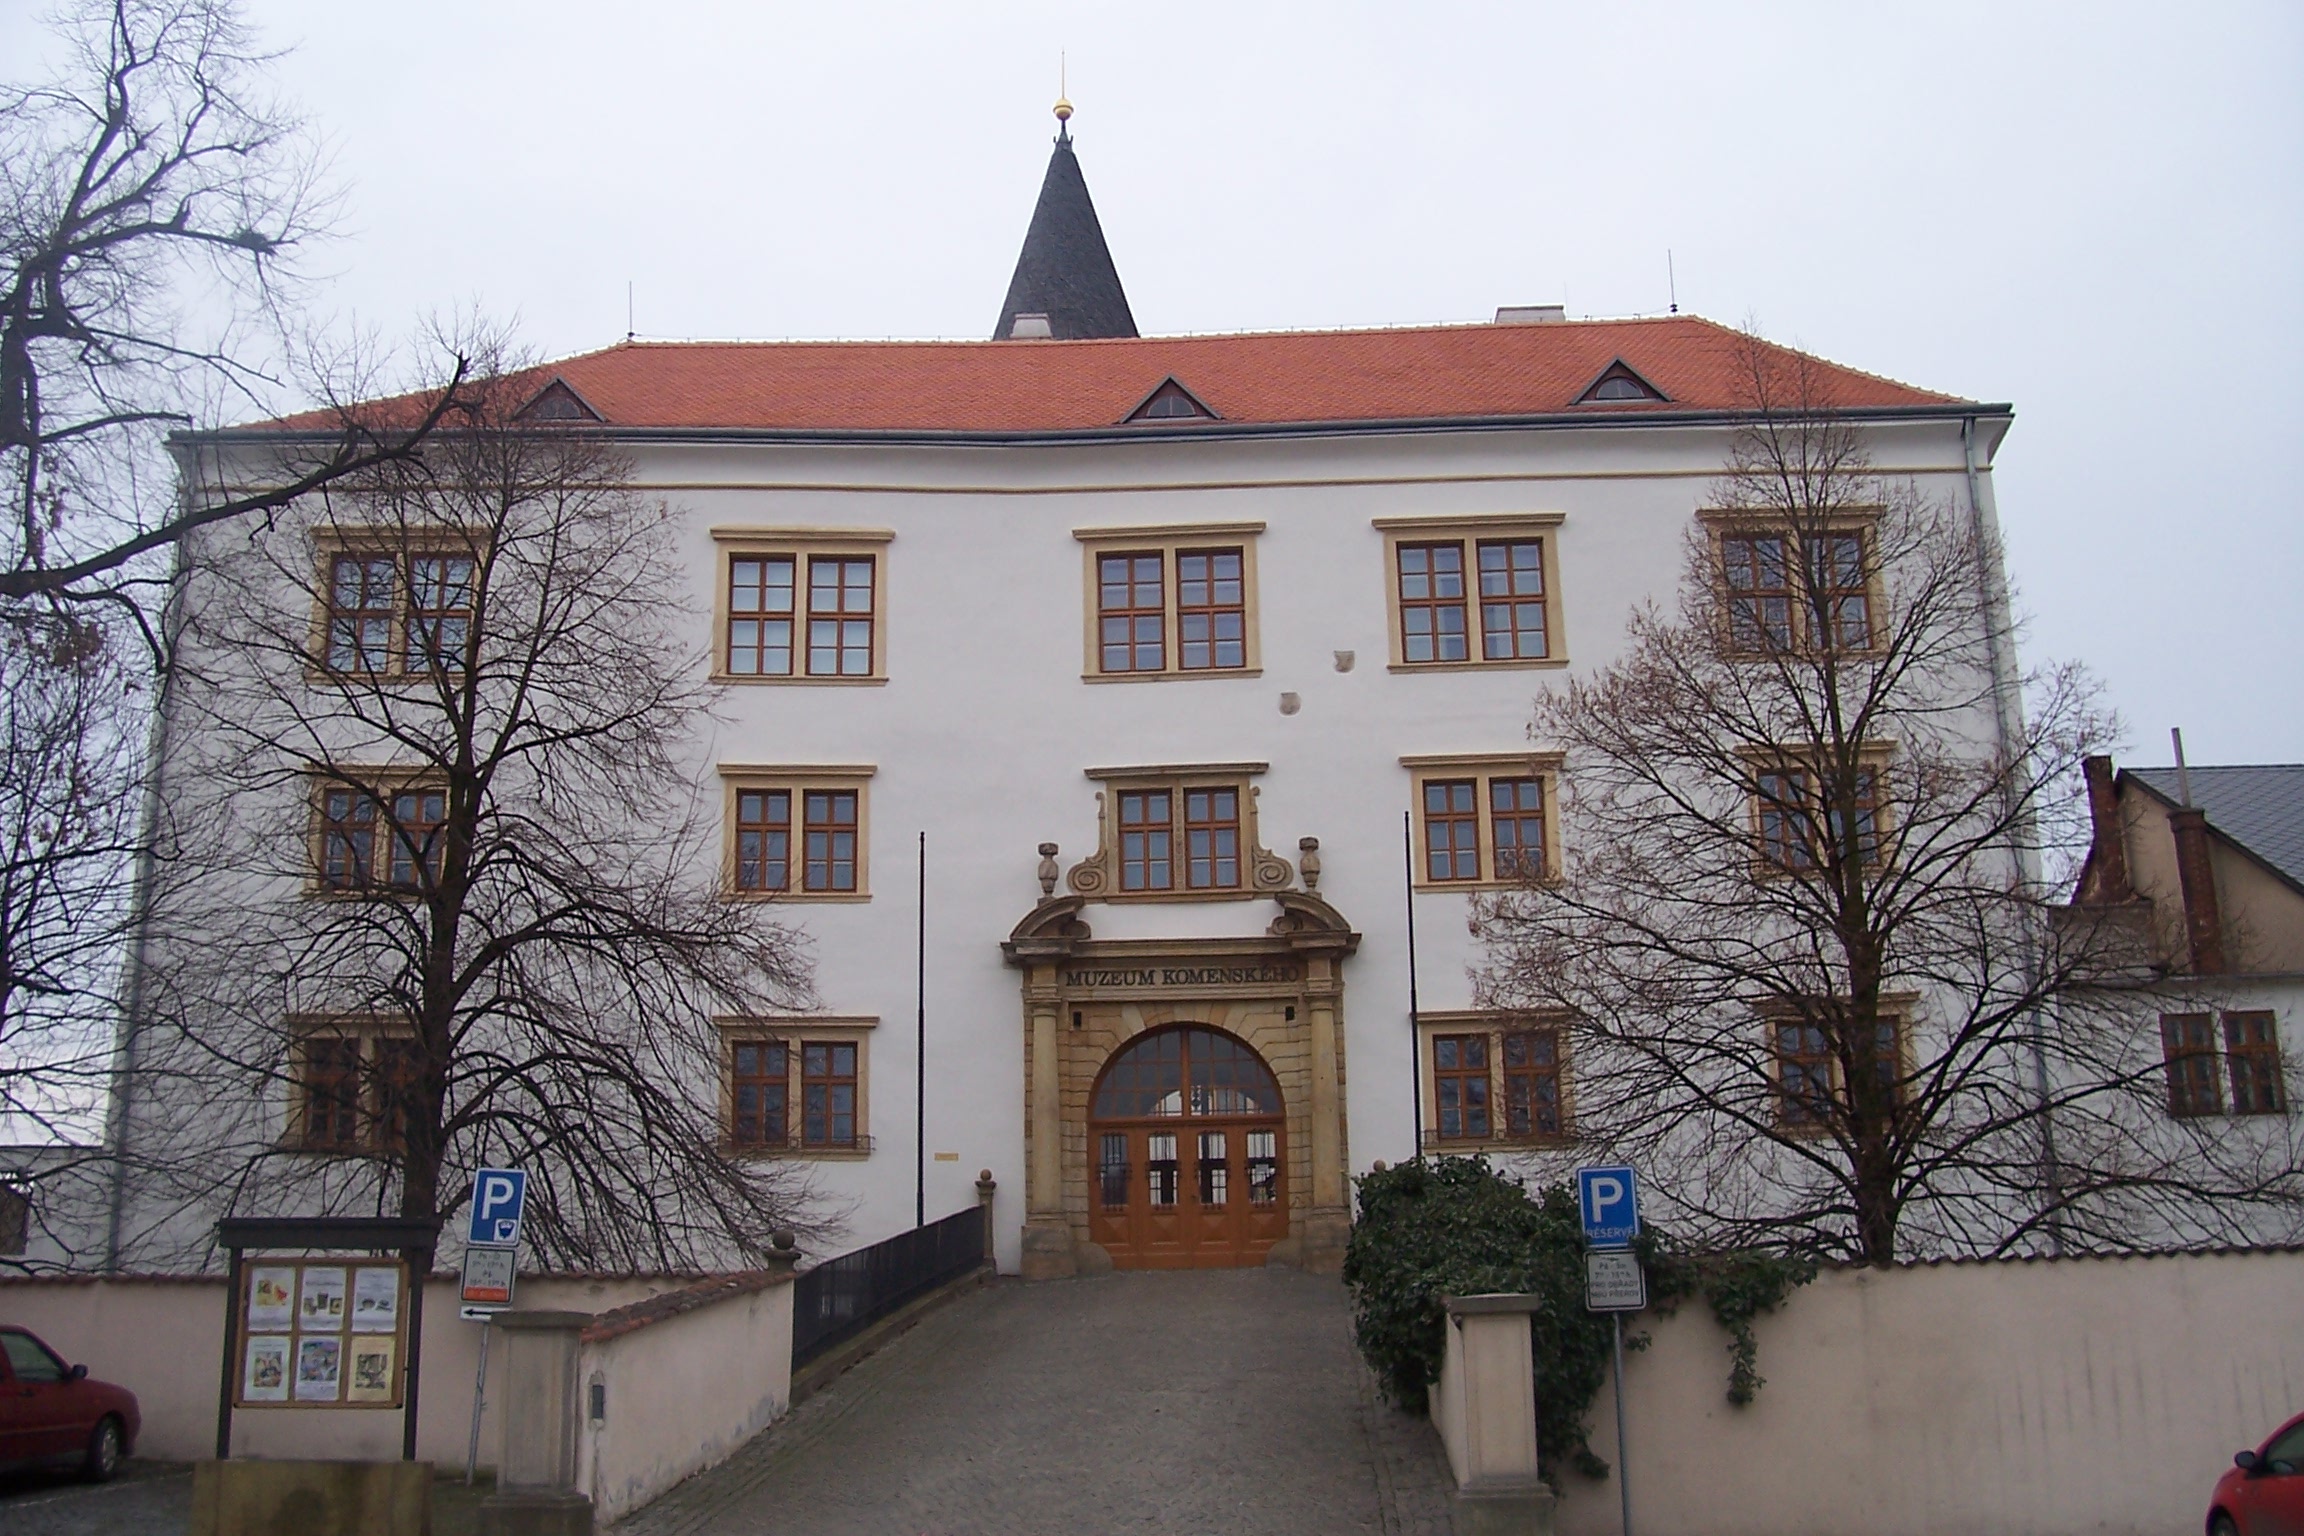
[1558,1250,2304,1536]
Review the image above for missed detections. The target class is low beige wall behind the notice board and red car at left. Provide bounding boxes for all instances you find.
[0,1276,681,1467]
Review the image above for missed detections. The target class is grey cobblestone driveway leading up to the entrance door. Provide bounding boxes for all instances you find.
[615,1269,1449,1536]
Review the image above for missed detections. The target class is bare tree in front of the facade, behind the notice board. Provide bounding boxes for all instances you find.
[114,345,813,1269]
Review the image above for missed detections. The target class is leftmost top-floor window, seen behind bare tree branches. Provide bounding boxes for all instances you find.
[320,550,479,675]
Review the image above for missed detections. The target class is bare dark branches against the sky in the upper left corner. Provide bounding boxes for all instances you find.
[0,0,463,617]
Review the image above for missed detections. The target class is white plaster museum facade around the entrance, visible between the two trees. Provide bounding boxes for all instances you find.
[130,412,1999,1269]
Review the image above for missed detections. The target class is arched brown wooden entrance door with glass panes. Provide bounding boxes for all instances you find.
[1087,1025,1288,1269]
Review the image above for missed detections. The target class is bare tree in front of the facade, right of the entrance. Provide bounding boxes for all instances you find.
[1477,339,2304,1264]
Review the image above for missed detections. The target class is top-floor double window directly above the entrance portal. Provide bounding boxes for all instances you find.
[1094,546,1249,677]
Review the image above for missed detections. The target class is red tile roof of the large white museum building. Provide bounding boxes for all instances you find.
[264,315,1958,433]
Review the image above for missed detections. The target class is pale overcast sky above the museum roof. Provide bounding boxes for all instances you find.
[0,0,2304,762]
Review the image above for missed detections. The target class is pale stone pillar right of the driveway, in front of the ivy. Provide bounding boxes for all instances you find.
[1431,1297,1553,1536]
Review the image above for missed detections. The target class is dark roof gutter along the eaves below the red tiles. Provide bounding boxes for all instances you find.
[170,401,2016,447]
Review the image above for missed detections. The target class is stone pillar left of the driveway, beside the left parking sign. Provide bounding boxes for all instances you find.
[479,1313,592,1536]
